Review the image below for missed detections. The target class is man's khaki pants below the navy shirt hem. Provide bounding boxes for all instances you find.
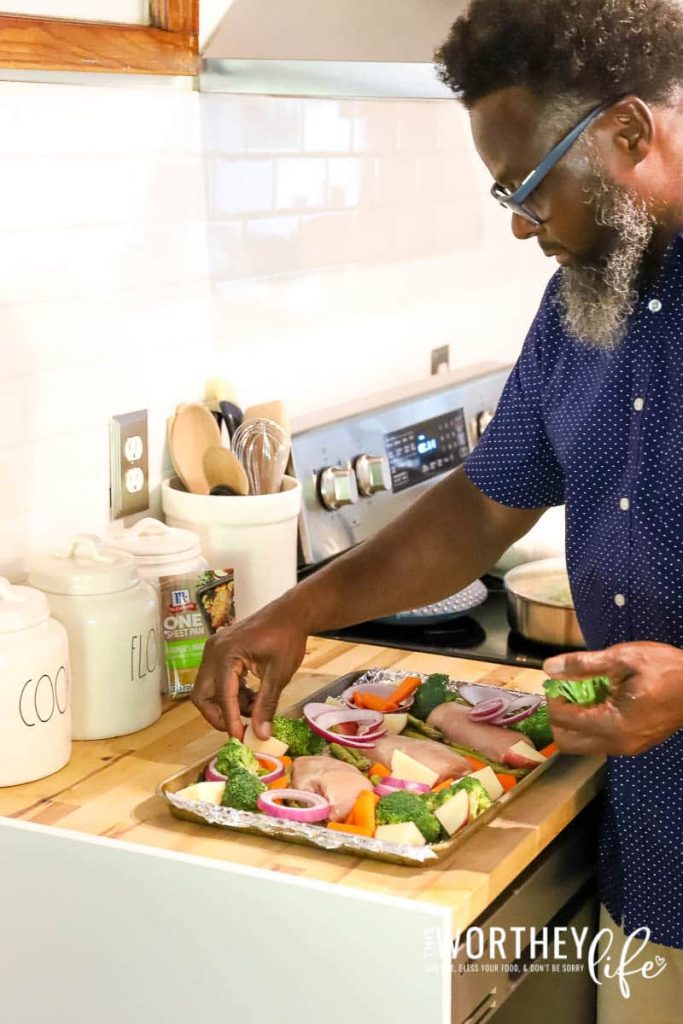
[597,906,683,1024]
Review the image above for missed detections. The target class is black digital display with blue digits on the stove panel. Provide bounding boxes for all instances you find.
[384,409,470,494]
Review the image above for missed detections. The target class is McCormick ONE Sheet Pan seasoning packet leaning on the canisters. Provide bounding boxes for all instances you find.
[159,569,234,699]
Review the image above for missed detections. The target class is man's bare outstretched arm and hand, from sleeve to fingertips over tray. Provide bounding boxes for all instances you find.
[193,469,545,737]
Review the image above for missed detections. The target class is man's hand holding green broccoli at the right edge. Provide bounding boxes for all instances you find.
[543,641,683,755]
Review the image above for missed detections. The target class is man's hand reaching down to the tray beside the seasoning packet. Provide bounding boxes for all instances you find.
[191,601,308,739]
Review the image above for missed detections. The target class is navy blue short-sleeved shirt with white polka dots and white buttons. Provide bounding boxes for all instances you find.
[465,232,683,948]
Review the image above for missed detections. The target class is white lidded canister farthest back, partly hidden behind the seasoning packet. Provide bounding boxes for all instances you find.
[106,516,209,693]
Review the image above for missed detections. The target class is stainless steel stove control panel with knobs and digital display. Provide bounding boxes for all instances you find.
[292,364,511,565]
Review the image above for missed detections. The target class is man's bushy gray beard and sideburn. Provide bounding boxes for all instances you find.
[557,170,654,350]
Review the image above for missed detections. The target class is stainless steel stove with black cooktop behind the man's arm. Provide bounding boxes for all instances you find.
[292,364,573,667]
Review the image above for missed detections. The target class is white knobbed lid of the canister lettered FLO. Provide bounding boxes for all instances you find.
[29,534,137,595]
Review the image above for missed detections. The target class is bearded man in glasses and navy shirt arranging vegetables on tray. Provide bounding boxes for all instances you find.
[194,0,683,1022]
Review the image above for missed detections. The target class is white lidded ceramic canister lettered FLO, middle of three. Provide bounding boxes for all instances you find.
[29,535,161,739]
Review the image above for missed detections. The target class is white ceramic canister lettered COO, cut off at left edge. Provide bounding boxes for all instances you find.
[0,577,71,786]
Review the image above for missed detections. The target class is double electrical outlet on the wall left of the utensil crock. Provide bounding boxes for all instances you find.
[110,409,150,519]
